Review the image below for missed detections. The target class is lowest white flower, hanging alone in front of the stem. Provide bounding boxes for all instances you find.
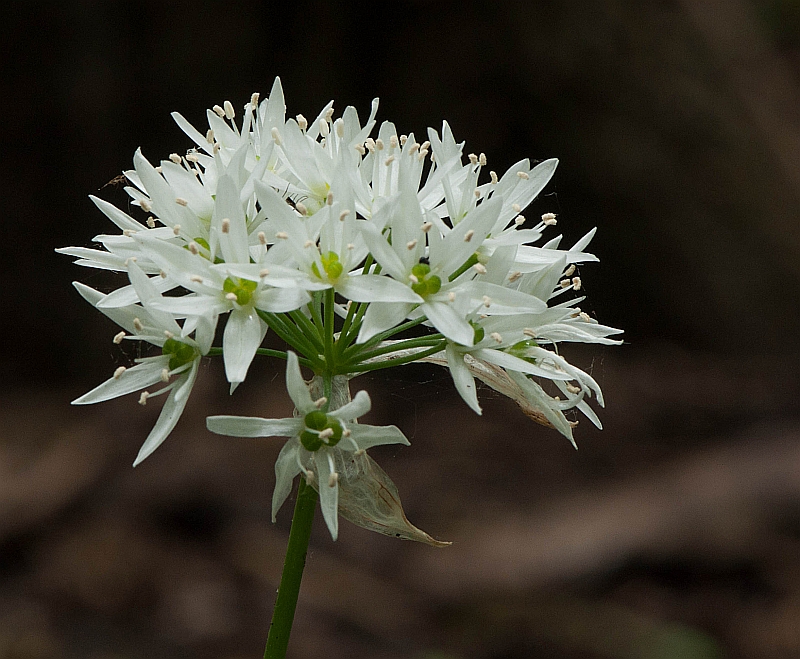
[206,352,409,540]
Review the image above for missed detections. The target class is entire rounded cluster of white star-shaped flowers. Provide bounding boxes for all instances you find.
[59,80,619,536]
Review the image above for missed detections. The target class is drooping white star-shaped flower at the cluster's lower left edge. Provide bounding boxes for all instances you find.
[72,262,209,467]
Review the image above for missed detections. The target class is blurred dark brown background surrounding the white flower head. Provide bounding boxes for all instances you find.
[0,0,800,659]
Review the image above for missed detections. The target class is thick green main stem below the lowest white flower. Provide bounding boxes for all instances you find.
[264,476,317,659]
